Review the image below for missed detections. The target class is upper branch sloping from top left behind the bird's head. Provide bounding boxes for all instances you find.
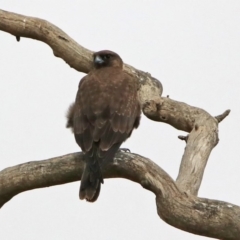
[0,10,162,104]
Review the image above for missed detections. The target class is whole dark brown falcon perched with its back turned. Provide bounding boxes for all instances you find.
[67,50,141,202]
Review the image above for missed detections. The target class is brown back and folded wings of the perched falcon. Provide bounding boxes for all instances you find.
[74,68,141,156]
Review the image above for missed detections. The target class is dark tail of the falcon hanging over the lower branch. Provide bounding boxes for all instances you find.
[79,156,103,202]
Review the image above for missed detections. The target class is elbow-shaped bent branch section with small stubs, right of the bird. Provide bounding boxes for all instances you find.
[143,97,223,196]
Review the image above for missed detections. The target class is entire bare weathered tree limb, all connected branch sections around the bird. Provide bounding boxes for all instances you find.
[0,10,240,239]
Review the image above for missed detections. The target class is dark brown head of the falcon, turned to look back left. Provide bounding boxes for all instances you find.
[93,50,123,69]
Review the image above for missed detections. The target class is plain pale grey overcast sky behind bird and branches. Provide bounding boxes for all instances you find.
[0,0,240,240]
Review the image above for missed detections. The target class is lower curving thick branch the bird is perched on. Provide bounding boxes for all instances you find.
[0,153,240,239]
